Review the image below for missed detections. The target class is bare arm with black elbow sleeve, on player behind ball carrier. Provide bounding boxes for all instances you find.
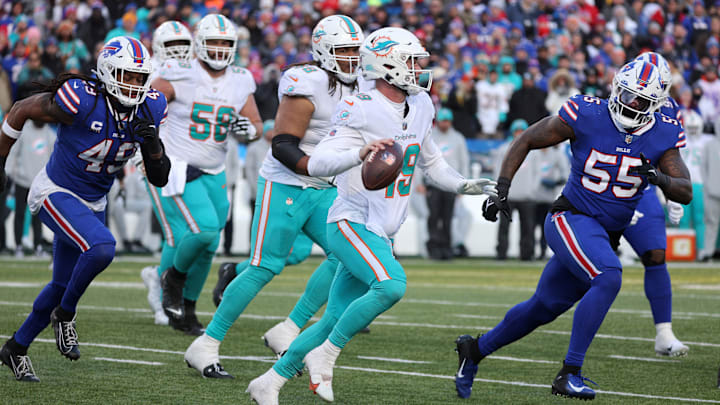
[272,95,315,175]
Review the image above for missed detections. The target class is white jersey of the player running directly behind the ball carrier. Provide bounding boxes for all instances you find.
[260,65,355,188]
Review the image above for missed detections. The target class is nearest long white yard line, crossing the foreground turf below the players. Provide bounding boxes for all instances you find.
[0,335,720,404]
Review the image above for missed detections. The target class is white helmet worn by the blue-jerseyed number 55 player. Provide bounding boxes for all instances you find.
[608,61,665,130]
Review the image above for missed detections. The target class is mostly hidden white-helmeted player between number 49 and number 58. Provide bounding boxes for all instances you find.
[140,20,192,325]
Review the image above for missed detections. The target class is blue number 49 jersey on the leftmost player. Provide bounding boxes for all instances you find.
[45,79,167,202]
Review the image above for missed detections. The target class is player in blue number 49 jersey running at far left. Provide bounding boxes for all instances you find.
[0,37,170,382]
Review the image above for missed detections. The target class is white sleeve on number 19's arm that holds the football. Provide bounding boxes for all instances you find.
[308,126,365,177]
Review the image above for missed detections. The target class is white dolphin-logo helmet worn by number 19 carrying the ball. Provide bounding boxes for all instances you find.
[360,27,432,95]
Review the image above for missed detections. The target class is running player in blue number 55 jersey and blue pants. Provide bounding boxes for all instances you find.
[455,61,692,399]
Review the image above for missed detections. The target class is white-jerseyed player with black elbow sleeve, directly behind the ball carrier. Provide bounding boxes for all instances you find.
[185,15,364,377]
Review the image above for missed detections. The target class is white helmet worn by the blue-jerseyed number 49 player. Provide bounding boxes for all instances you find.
[96,37,152,107]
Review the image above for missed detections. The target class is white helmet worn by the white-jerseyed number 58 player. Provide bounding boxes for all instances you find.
[195,14,237,70]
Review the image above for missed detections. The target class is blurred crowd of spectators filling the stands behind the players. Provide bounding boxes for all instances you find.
[0,0,720,256]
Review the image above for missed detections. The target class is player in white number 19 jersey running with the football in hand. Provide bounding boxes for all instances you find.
[247,28,495,405]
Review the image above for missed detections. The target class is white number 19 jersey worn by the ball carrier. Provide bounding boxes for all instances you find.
[316,89,442,237]
